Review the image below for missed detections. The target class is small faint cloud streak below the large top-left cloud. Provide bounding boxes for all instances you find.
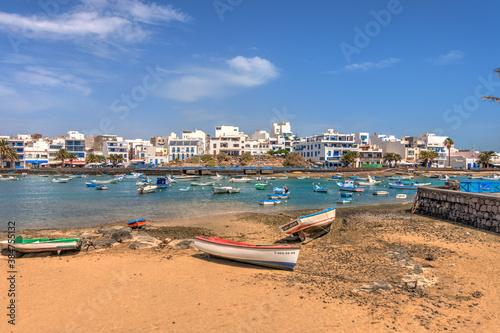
[14,66,92,96]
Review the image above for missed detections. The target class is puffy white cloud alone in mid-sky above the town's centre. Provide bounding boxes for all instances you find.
[159,56,279,102]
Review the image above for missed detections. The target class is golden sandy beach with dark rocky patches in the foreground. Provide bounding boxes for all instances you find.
[0,204,500,332]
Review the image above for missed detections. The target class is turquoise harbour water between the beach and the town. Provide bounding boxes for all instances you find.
[0,176,458,229]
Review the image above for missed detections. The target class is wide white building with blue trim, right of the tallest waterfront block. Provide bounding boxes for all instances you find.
[293,129,358,166]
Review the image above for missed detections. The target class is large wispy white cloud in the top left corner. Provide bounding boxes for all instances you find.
[0,0,191,48]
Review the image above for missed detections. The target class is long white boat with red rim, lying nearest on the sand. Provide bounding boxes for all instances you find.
[194,236,300,270]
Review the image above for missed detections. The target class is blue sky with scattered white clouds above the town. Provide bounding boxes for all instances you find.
[0,0,500,151]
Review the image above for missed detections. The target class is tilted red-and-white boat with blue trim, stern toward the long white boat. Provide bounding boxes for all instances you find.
[279,207,337,235]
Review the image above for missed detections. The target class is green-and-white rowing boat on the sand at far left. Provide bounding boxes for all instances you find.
[9,236,81,254]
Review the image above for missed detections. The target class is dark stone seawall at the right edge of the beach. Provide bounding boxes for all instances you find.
[414,186,500,233]
